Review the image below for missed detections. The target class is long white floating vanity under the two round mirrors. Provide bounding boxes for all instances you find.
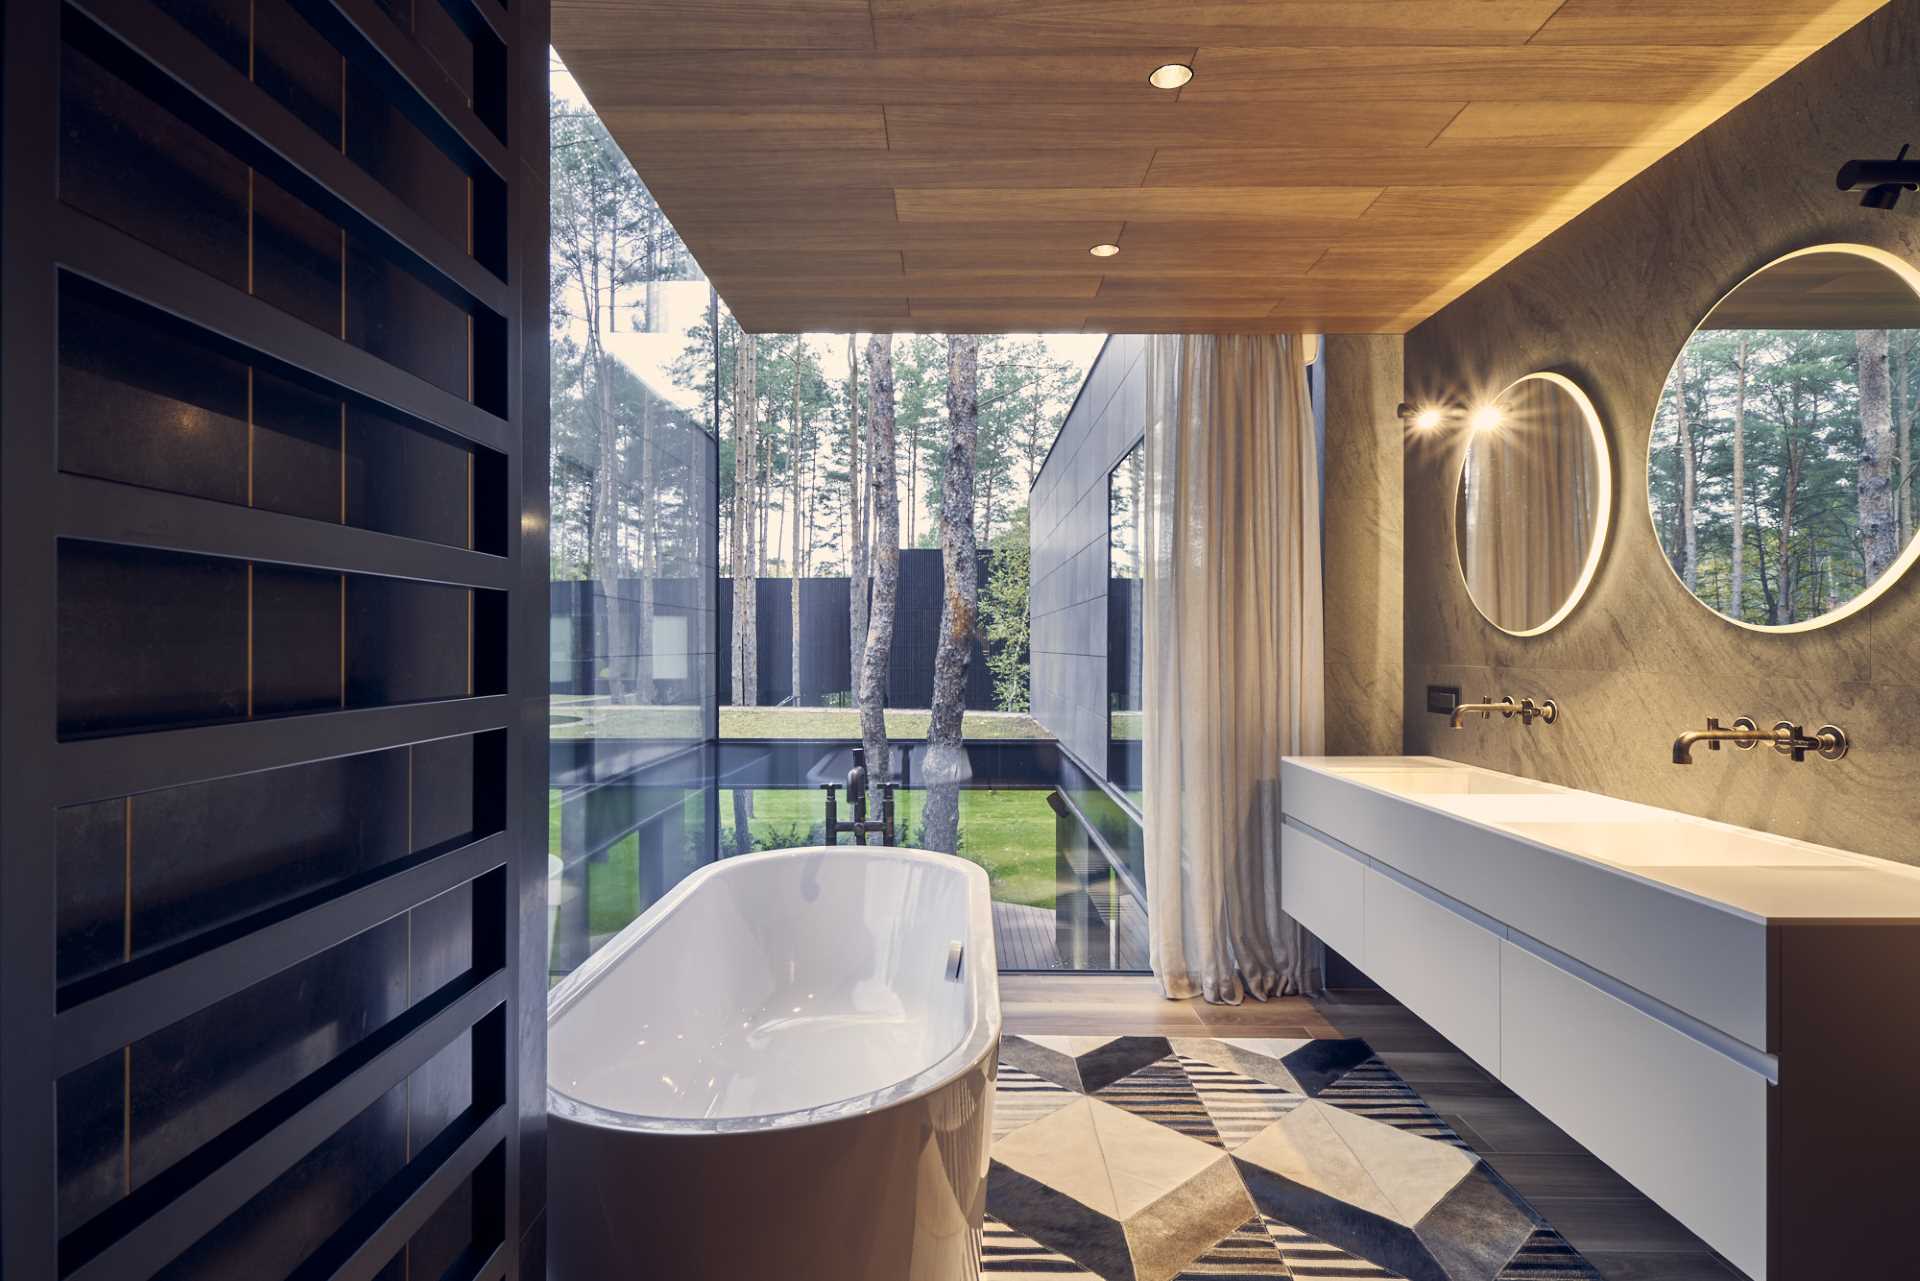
[1281,757,1920,1281]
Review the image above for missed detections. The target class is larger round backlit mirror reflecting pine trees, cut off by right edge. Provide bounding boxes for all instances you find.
[1647,244,1920,632]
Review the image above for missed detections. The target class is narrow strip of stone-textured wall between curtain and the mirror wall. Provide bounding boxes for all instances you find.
[1321,334,1405,757]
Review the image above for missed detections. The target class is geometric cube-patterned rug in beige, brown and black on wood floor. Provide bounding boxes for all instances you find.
[981,1035,1597,1281]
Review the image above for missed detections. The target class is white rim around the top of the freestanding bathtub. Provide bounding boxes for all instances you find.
[547,845,1000,1135]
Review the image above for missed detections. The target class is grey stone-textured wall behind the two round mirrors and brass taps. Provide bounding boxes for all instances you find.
[1405,0,1920,862]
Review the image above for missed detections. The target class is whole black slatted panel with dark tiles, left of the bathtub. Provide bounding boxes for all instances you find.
[0,0,547,1281]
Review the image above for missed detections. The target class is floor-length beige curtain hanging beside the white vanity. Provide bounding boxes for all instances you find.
[1142,336,1325,1004]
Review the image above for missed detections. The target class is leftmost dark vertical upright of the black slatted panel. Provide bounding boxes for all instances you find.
[0,0,60,1277]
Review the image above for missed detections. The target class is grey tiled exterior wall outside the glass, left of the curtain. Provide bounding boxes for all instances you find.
[1029,334,1146,776]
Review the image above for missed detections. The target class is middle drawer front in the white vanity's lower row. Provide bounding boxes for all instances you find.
[1365,868,1501,1076]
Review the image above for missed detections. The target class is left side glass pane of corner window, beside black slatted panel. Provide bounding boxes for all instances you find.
[547,73,726,978]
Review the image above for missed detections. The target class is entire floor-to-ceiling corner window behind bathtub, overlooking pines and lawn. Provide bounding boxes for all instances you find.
[549,61,1117,979]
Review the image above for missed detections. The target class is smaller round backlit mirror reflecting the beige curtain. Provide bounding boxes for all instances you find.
[1453,373,1613,636]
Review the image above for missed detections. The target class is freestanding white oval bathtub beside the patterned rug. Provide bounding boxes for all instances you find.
[547,845,1000,1281]
